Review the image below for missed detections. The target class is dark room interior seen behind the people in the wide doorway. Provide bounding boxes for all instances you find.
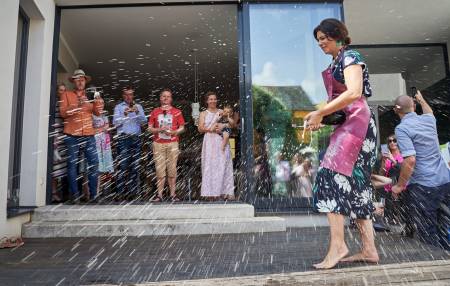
[47,1,240,202]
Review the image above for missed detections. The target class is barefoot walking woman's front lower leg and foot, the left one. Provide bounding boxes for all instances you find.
[314,213,348,269]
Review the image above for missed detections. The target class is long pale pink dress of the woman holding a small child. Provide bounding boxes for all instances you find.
[201,110,234,197]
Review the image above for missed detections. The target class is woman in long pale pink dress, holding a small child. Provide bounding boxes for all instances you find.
[198,92,234,200]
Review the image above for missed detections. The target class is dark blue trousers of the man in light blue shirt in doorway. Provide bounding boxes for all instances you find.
[117,134,141,194]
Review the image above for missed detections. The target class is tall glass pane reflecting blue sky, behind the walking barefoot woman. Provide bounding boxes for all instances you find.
[250,4,340,197]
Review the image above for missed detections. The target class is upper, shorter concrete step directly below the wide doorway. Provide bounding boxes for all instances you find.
[32,203,255,222]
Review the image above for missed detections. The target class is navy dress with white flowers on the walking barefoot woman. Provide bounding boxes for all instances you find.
[313,49,377,219]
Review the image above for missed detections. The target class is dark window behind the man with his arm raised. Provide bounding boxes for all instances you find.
[356,44,450,146]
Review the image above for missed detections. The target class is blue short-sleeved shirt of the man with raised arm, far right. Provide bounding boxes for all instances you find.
[395,112,450,187]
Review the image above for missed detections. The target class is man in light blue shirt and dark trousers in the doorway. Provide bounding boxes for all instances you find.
[113,87,147,200]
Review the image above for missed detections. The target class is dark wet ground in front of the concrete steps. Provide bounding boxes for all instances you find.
[0,228,450,285]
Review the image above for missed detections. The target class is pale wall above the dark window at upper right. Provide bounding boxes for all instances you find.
[343,0,450,69]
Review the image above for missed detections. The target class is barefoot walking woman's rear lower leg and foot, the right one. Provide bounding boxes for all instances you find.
[341,219,380,263]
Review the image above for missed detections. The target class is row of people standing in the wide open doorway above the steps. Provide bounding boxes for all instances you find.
[55,69,236,204]
